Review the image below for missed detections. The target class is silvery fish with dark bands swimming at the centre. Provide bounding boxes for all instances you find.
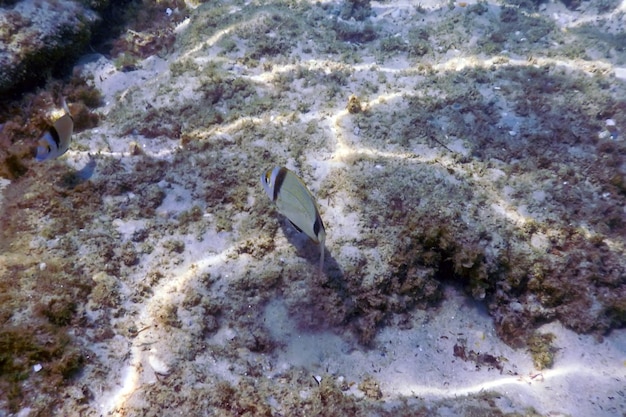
[261,167,326,275]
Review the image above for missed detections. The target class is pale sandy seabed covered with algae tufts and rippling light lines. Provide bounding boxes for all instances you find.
[0,1,626,417]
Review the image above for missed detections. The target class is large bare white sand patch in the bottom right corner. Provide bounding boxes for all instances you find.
[264,288,626,417]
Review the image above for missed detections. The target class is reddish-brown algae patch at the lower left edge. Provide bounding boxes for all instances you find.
[0,254,89,415]
